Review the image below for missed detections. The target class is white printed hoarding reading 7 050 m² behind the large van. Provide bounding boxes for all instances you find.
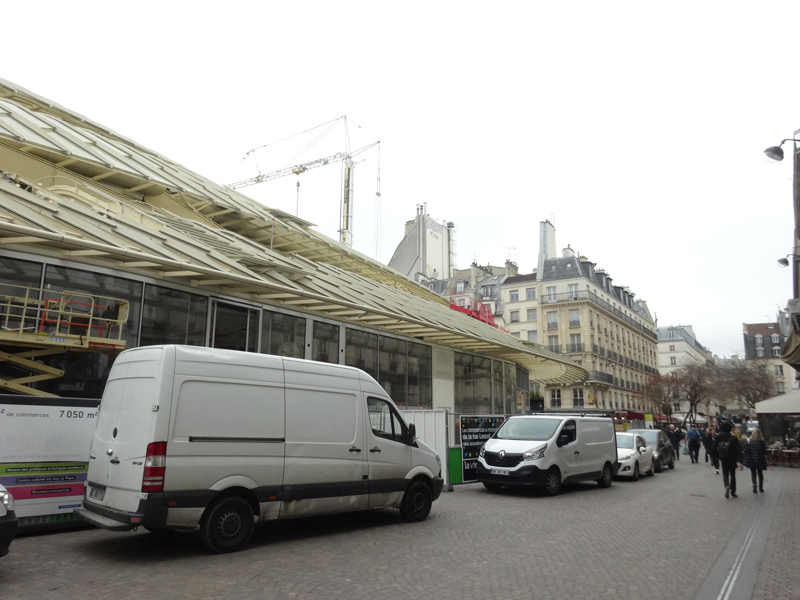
[0,396,100,518]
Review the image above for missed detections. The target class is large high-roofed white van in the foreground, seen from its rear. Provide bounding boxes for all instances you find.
[75,346,443,552]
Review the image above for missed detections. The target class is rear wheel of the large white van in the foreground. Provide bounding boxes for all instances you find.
[200,496,255,553]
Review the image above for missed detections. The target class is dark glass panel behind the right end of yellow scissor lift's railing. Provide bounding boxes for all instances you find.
[44,265,142,348]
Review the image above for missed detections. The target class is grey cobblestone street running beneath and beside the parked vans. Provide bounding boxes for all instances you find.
[0,460,800,600]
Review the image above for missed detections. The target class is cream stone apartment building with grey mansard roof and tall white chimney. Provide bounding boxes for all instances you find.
[501,221,658,411]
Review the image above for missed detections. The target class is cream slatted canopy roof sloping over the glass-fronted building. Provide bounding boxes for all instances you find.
[0,79,588,384]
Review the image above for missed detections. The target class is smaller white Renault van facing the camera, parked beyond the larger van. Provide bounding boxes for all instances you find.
[478,413,619,496]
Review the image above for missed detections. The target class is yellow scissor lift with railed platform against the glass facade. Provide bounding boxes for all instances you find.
[0,284,130,396]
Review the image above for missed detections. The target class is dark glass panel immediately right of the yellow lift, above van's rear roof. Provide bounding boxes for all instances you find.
[139,284,208,346]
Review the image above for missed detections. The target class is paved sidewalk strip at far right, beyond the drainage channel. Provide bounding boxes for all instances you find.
[742,467,800,600]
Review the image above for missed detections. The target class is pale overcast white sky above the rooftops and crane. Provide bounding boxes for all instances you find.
[0,0,800,356]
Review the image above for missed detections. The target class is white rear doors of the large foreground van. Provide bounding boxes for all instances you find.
[87,347,163,512]
